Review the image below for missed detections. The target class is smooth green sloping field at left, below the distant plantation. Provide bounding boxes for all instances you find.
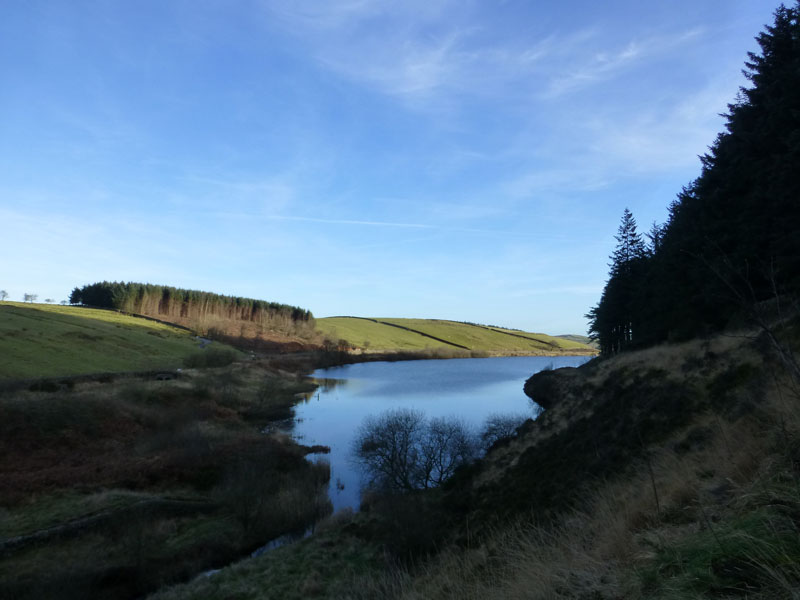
[0,302,212,379]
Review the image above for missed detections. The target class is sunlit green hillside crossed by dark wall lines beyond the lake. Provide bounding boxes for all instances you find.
[317,317,594,354]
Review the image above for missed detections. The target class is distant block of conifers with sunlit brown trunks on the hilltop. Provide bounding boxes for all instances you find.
[70,281,314,345]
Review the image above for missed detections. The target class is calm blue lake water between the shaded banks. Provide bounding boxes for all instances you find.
[293,356,590,511]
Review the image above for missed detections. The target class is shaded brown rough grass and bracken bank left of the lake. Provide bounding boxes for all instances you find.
[0,361,330,598]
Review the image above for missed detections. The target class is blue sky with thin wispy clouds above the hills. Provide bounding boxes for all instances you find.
[0,0,777,334]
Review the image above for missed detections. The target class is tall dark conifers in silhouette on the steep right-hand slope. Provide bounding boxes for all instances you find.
[587,1,800,355]
